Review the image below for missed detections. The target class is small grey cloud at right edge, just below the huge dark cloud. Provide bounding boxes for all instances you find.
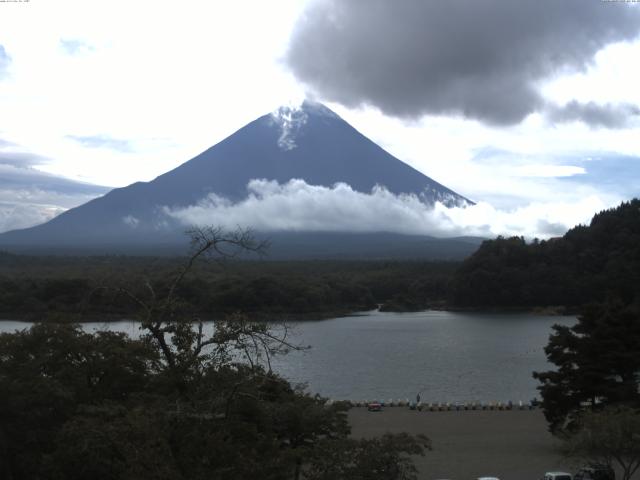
[547,100,640,128]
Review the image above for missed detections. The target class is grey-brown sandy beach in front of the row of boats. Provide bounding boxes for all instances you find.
[349,407,576,480]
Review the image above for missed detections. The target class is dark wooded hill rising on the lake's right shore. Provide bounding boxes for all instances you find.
[451,199,640,308]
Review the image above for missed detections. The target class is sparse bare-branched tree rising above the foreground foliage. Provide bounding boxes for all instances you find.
[113,227,300,377]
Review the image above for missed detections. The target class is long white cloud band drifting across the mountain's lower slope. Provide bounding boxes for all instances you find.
[164,180,608,238]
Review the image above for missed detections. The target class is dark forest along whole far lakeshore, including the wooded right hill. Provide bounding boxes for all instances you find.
[5,200,640,321]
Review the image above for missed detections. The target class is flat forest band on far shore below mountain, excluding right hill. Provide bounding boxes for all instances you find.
[0,253,458,321]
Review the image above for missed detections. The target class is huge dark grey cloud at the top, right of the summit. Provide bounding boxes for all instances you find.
[286,0,640,125]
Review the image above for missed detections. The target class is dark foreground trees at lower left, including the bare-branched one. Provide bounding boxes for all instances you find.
[0,229,424,480]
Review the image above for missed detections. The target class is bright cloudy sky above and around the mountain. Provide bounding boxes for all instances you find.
[0,0,640,235]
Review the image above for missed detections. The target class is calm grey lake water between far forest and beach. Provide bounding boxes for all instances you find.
[0,311,576,403]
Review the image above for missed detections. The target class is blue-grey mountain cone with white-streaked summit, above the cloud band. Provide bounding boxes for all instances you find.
[0,102,469,251]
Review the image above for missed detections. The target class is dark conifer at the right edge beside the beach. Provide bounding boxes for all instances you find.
[534,302,640,432]
